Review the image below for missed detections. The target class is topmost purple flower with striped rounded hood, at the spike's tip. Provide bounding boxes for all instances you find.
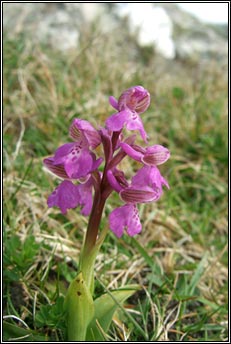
[106,86,150,141]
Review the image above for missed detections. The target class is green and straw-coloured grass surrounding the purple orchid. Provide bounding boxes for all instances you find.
[3,26,228,341]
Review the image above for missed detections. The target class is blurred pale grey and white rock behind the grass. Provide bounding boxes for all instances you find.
[3,2,228,63]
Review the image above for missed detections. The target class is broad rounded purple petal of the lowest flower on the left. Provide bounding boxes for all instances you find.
[47,180,80,214]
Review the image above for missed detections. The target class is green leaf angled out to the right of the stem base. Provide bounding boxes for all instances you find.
[86,286,140,341]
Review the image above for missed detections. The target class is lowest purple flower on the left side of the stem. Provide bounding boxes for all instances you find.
[47,178,92,215]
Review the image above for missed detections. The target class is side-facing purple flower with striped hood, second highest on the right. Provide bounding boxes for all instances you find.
[120,142,170,166]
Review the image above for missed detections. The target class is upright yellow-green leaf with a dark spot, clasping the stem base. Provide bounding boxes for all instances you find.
[65,272,94,341]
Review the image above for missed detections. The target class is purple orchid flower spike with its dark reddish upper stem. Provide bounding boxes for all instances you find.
[44,86,170,238]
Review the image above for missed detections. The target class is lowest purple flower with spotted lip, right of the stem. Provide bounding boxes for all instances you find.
[109,204,142,238]
